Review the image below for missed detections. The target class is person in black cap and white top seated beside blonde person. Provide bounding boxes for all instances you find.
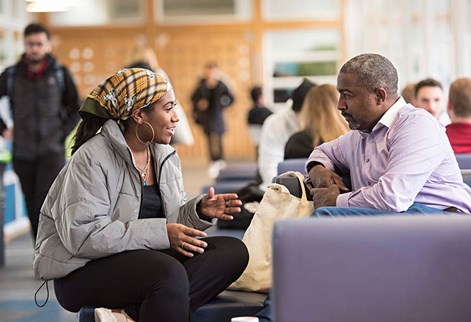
[258,78,315,190]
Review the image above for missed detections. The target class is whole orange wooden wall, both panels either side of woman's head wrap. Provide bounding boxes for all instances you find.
[53,29,255,160]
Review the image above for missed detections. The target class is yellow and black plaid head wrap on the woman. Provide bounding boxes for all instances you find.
[79,68,171,123]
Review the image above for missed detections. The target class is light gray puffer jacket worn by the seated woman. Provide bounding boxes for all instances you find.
[33,120,215,280]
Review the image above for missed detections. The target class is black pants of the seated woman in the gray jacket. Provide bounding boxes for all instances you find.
[54,237,248,322]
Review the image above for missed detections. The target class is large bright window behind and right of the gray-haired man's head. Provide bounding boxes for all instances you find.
[345,0,471,91]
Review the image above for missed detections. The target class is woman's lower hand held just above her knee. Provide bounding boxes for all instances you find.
[167,224,208,257]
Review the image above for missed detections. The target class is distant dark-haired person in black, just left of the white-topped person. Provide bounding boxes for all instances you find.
[247,86,273,148]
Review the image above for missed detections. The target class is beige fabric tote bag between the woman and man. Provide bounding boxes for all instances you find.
[229,171,314,292]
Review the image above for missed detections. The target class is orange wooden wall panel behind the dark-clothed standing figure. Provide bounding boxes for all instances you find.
[156,31,255,160]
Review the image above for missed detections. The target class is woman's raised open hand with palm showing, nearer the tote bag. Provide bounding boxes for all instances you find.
[197,187,242,220]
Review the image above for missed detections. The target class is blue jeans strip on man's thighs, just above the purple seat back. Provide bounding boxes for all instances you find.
[311,203,453,217]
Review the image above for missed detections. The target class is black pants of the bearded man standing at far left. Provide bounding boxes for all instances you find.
[13,153,65,242]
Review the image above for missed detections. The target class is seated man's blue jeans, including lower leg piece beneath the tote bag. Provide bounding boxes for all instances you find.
[256,203,453,322]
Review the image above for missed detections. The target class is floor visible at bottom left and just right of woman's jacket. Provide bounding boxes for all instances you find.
[0,163,227,322]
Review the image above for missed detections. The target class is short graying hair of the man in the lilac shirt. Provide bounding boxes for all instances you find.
[340,54,398,94]
